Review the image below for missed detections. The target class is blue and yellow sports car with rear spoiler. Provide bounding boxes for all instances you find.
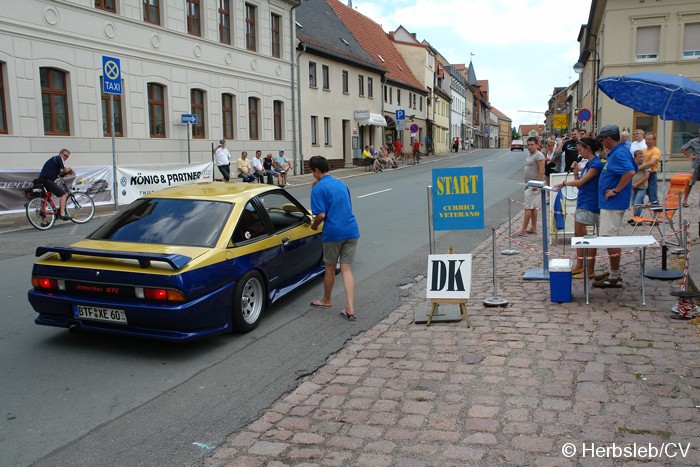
[28,183,324,341]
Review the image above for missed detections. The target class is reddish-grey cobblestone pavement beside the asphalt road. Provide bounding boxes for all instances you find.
[203,204,700,466]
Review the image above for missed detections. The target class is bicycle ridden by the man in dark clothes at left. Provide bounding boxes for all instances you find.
[24,177,95,230]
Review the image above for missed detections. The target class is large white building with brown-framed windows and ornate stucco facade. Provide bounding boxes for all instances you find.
[0,0,299,172]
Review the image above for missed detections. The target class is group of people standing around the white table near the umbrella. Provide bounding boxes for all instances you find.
[515,125,664,288]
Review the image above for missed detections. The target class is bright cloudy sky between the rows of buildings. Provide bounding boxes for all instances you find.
[356,0,591,128]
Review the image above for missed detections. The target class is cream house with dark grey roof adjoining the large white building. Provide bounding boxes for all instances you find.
[296,0,387,171]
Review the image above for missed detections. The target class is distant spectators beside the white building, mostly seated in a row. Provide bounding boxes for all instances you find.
[214,139,292,187]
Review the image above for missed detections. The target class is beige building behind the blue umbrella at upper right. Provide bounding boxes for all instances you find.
[577,0,700,161]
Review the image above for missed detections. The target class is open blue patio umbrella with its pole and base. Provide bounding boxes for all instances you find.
[597,72,700,279]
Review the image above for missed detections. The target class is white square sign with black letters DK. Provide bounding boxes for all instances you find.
[426,255,472,299]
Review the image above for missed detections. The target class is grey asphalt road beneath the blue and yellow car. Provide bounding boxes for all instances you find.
[0,150,524,466]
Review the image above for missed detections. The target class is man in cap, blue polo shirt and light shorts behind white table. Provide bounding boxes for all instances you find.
[592,125,637,288]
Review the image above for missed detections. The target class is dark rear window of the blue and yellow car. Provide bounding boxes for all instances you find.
[88,198,233,247]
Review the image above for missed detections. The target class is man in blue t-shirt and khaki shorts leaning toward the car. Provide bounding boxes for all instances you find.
[309,156,360,321]
